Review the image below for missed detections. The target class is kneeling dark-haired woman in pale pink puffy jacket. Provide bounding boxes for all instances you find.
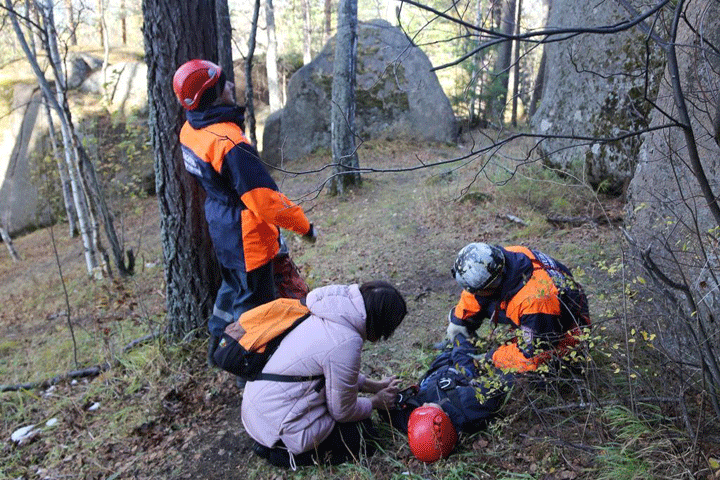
[242,281,407,468]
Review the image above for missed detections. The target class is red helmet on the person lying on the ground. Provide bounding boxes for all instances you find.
[408,405,457,463]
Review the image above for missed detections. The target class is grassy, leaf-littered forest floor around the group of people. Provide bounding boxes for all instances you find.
[0,133,720,480]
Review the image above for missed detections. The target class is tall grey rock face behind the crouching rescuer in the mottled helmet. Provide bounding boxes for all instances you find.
[531,0,664,191]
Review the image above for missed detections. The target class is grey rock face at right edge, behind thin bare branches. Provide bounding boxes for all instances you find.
[627,1,720,326]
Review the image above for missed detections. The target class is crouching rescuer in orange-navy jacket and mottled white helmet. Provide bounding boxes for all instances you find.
[447,243,590,372]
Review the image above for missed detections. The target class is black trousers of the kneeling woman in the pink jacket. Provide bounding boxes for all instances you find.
[253,418,377,468]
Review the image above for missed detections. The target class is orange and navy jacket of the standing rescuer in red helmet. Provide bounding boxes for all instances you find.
[180,105,310,271]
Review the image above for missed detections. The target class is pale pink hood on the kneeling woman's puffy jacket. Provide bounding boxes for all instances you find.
[306,284,367,341]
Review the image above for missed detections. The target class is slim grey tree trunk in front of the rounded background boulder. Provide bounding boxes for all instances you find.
[330,0,361,195]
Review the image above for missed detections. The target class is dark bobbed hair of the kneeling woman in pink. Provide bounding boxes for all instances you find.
[360,280,407,342]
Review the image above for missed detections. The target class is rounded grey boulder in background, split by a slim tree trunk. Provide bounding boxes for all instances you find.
[262,20,458,165]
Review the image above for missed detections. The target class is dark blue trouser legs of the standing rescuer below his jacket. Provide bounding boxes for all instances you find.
[208,261,276,337]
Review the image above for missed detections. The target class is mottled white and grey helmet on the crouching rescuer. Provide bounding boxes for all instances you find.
[452,243,505,293]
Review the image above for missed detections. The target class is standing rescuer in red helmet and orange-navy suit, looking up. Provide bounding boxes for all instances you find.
[173,60,316,365]
